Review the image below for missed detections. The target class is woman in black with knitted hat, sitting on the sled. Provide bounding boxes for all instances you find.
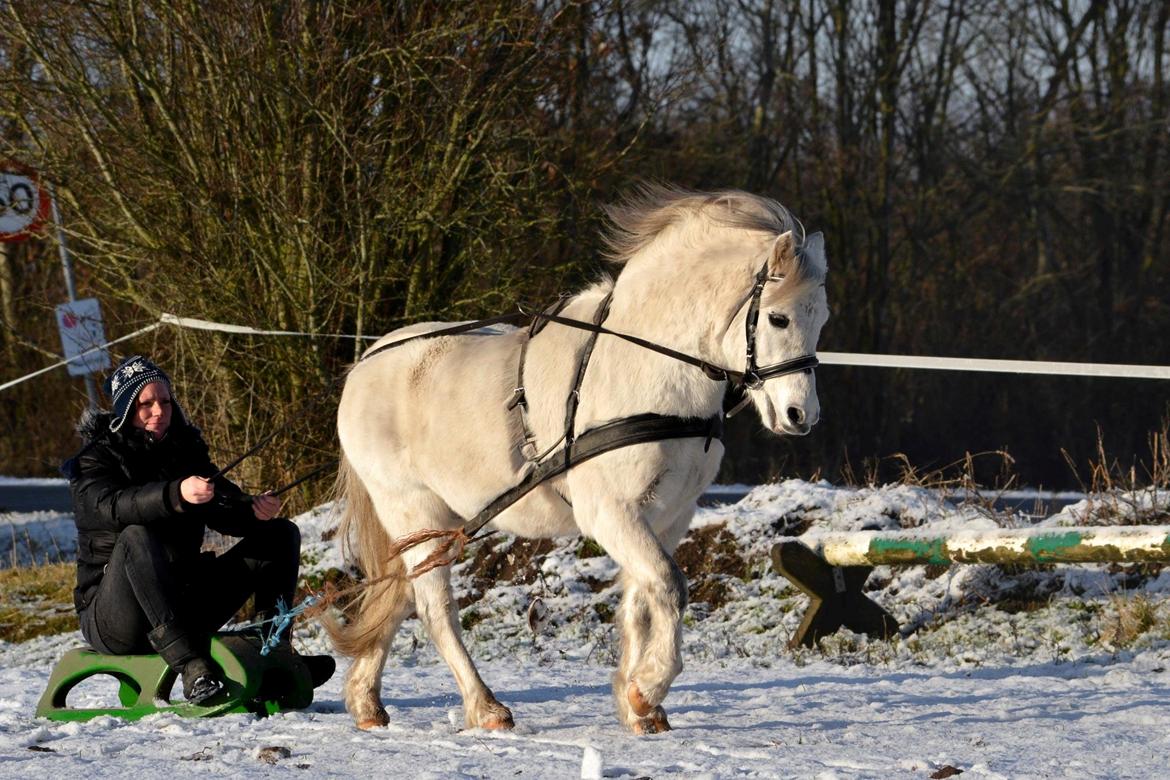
[61,356,333,704]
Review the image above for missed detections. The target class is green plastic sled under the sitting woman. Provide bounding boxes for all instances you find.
[36,634,312,720]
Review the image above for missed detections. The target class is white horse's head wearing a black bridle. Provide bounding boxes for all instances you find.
[724,232,828,436]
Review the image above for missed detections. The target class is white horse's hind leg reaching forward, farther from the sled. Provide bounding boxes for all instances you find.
[404,543,514,729]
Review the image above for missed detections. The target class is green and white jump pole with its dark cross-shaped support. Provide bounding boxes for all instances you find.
[772,525,1170,647]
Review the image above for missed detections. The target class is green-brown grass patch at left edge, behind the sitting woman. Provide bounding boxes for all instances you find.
[0,564,77,642]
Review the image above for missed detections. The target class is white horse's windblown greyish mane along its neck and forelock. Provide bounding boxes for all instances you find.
[604,184,824,284]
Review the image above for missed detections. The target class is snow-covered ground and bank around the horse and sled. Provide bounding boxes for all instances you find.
[0,482,1170,780]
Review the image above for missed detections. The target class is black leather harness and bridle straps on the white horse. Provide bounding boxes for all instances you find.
[362,261,819,537]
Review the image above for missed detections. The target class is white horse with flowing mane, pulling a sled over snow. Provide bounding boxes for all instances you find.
[331,188,828,733]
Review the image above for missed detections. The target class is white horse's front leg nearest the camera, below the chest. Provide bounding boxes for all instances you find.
[582,505,687,733]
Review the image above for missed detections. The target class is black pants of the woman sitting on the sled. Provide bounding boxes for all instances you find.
[80,518,301,655]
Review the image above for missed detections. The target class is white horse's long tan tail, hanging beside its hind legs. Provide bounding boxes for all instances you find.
[322,453,411,657]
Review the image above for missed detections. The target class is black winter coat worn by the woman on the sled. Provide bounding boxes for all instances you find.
[61,412,259,612]
